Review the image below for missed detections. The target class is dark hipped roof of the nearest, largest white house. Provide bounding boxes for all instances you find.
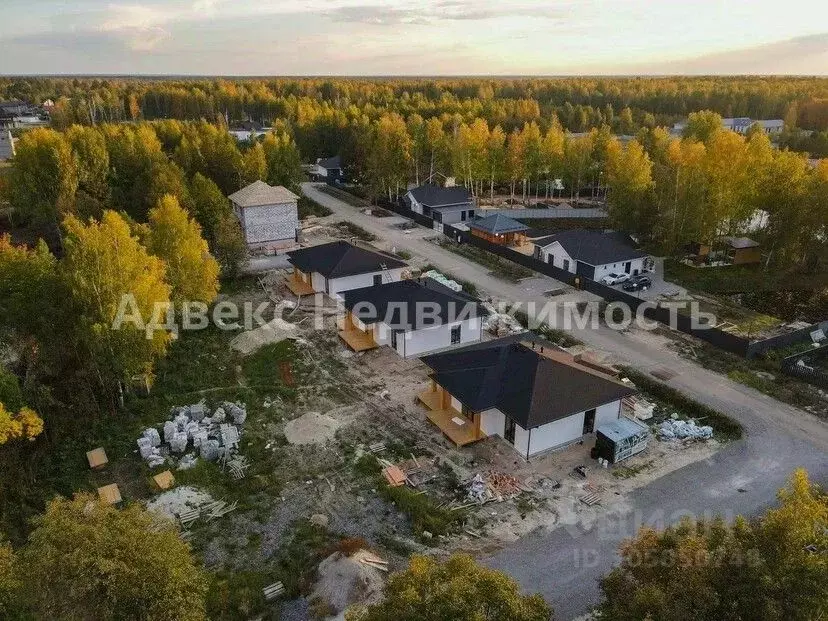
[422,332,636,429]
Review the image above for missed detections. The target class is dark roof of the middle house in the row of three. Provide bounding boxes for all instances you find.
[343,278,488,330]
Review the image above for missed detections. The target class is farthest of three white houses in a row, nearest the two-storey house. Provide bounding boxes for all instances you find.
[287,241,408,299]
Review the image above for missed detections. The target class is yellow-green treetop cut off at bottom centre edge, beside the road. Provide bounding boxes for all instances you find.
[345,554,552,621]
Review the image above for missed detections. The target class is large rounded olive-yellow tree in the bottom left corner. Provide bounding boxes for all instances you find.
[18,494,207,621]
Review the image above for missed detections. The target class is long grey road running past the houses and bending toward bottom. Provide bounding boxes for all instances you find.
[302,183,828,620]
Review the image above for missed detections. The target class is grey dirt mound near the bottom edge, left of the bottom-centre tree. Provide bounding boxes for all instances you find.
[309,550,385,621]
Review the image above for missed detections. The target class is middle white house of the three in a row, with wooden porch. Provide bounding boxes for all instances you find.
[339,278,486,358]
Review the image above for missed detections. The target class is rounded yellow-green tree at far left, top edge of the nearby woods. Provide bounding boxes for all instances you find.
[11,128,78,233]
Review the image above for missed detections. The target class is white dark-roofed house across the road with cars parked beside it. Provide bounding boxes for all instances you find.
[534,229,653,281]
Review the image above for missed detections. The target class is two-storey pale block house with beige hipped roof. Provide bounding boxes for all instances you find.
[229,181,299,253]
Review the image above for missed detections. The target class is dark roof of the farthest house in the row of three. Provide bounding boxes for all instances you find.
[287,241,408,278]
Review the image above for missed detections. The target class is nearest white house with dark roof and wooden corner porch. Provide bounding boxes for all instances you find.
[419,332,636,459]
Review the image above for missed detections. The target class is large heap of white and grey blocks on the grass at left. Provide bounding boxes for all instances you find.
[137,401,247,470]
